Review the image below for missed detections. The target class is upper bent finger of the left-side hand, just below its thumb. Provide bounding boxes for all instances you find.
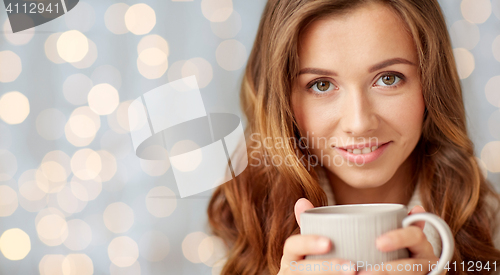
[281,235,331,264]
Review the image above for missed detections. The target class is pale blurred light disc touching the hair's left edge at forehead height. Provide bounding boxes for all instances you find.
[215,39,247,71]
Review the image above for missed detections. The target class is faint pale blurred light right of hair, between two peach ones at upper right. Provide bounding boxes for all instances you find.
[450,20,480,50]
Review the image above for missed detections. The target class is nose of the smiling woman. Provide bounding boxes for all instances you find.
[341,88,378,136]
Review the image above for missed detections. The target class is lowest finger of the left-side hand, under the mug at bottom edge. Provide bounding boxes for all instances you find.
[282,259,357,275]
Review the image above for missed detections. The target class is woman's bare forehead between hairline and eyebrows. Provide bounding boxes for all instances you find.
[299,3,417,67]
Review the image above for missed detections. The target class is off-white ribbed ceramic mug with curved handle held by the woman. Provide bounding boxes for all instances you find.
[300,203,455,275]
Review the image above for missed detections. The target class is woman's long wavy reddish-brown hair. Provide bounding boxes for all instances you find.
[207,0,500,275]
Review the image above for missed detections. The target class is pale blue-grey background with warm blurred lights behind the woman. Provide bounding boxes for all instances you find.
[0,0,500,275]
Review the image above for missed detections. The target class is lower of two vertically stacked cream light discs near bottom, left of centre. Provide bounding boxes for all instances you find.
[108,236,139,267]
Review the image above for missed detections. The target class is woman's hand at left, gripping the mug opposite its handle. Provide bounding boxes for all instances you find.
[278,198,356,275]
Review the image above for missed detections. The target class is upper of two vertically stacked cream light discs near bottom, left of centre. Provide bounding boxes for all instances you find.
[103,202,134,233]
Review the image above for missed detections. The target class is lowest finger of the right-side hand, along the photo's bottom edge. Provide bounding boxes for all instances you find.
[357,259,430,275]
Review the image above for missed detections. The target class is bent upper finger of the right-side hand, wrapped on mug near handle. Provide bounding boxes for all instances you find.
[376,225,434,258]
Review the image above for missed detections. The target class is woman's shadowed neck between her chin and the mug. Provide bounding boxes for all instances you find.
[325,155,416,205]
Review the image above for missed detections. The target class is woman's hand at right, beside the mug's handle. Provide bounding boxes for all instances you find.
[358,205,446,275]
